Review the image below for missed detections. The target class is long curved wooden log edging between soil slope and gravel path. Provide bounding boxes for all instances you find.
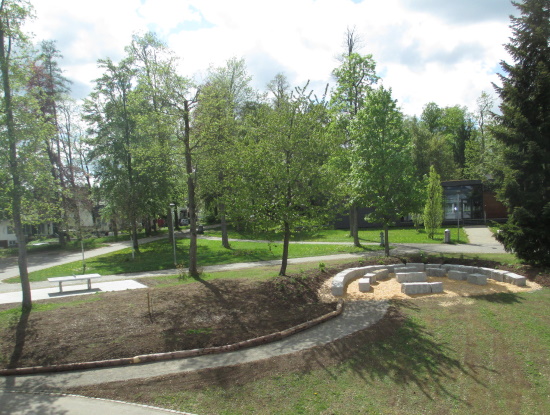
[0,300,344,376]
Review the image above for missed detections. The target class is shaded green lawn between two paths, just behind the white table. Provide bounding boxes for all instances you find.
[4,239,381,283]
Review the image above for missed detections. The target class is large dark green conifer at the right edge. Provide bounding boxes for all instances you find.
[493,0,550,264]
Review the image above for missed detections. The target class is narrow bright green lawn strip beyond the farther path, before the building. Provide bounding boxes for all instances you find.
[205,226,468,244]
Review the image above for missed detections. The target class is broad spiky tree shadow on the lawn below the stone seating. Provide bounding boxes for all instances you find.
[300,301,492,406]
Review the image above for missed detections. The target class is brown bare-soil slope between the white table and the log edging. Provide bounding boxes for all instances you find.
[0,275,336,368]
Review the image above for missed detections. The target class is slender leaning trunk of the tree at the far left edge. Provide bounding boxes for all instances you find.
[0,27,32,310]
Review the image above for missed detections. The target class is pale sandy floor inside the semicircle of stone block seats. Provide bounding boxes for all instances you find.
[319,274,542,305]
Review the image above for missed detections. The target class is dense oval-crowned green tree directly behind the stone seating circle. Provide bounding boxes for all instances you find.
[350,87,419,256]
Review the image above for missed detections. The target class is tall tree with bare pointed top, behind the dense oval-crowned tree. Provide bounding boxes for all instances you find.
[331,29,378,246]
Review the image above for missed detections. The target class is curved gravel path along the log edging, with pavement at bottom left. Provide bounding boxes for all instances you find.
[0,301,388,415]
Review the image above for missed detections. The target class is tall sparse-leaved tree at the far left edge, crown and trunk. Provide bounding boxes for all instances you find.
[0,0,51,310]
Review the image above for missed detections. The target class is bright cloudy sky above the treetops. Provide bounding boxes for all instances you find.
[26,0,517,115]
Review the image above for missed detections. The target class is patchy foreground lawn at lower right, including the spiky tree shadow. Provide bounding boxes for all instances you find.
[151,289,550,415]
